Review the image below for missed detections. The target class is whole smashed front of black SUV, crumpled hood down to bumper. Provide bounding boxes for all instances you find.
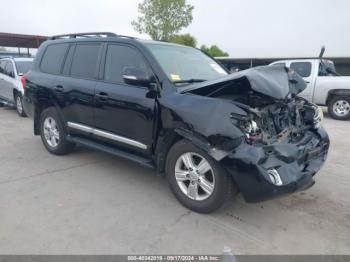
[175,66,329,202]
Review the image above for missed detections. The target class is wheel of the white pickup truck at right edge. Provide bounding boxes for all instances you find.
[328,96,350,120]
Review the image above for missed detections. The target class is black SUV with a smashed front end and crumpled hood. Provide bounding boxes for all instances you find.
[24,33,329,213]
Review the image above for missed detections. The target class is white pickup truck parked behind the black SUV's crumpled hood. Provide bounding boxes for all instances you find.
[270,57,350,120]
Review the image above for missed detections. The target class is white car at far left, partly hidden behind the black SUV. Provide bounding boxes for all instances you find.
[0,57,33,117]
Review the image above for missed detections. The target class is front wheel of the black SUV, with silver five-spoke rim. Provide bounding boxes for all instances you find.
[166,140,232,213]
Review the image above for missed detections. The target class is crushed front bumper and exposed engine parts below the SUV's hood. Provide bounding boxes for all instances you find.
[223,97,329,202]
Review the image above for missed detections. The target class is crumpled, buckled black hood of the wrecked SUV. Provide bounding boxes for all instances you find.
[180,66,307,100]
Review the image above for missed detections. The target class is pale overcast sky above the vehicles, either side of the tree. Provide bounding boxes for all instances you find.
[0,0,350,58]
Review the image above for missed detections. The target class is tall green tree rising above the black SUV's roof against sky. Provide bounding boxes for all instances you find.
[131,0,194,41]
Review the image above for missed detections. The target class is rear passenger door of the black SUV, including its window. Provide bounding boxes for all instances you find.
[53,42,102,135]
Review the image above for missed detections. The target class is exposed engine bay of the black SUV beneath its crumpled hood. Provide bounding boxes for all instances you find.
[186,71,322,145]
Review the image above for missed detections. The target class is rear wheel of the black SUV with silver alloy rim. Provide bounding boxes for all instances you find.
[40,107,74,155]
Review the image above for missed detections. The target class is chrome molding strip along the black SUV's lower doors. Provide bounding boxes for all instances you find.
[67,122,147,150]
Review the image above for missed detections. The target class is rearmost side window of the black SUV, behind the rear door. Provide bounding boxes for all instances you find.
[40,44,68,75]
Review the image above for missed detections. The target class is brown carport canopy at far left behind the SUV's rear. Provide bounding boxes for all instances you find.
[0,33,48,48]
